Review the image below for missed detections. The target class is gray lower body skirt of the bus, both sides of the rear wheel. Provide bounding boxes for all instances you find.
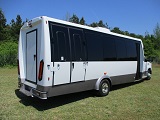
[18,74,142,99]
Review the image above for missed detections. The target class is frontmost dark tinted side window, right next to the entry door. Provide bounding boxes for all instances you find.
[126,40,137,61]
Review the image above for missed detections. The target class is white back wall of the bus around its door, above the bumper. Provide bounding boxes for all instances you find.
[18,19,44,85]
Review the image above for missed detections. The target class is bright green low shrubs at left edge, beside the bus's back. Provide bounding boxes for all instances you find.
[0,41,18,67]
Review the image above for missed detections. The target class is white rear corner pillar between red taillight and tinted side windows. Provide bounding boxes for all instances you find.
[37,19,53,86]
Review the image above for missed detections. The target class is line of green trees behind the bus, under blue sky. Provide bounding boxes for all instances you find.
[0,9,160,67]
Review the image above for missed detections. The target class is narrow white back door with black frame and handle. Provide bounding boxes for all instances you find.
[26,29,37,83]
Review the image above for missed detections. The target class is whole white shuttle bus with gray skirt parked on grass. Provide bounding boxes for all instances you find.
[18,16,150,99]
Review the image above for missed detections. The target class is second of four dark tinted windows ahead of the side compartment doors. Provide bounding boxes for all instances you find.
[103,35,116,61]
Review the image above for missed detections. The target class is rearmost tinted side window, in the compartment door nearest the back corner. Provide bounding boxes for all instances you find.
[50,23,70,62]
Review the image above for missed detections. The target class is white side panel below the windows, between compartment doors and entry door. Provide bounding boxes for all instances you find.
[85,61,137,80]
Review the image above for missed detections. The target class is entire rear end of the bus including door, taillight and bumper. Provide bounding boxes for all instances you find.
[18,17,50,99]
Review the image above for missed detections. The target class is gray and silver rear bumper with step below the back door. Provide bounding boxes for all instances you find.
[18,83,47,99]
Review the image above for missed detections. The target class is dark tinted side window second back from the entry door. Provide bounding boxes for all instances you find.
[115,37,127,61]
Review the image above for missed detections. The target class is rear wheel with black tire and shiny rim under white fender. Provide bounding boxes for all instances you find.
[97,80,111,97]
